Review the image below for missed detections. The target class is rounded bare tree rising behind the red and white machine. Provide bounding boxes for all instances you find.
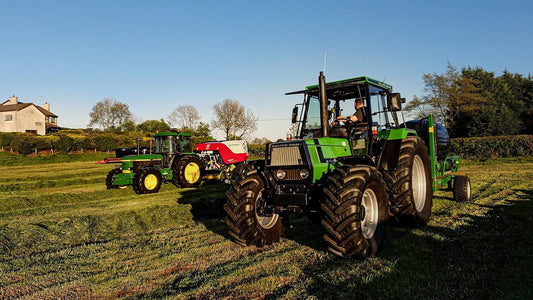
[213,99,258,139]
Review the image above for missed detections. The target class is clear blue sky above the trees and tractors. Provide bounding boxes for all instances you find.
[0,0,533,139]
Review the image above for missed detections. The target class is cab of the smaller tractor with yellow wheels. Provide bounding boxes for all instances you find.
[154,131,192,168]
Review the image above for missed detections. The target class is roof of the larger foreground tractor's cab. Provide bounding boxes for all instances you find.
[285,76,392,100]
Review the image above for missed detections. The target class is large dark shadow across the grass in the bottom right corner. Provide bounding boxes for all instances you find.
[296,190,533,299]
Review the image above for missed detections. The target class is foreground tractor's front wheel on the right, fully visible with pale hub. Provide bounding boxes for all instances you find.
[321,165,388,257]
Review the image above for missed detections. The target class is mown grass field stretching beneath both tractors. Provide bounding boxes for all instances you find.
[0,158,533,299]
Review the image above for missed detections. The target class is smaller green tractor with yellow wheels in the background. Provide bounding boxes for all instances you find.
[106,131,204,194]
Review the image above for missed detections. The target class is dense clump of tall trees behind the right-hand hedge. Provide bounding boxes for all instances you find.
[406,64,533,137]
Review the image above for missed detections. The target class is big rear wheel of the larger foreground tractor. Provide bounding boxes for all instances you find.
[391,137,433,224]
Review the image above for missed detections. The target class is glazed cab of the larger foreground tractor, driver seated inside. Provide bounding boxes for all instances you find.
[286,77,405,154]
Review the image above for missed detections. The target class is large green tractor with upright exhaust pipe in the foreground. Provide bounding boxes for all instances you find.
[224,72,469,257]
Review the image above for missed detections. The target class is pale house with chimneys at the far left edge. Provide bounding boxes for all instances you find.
[0,96,61,135]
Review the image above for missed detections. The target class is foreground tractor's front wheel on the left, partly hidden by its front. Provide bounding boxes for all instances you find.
[224,170,283,247]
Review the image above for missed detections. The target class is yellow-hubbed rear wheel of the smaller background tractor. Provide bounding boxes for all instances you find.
[172,155,204,188]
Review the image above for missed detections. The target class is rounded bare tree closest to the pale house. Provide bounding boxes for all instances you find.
[89,98,131,130]
